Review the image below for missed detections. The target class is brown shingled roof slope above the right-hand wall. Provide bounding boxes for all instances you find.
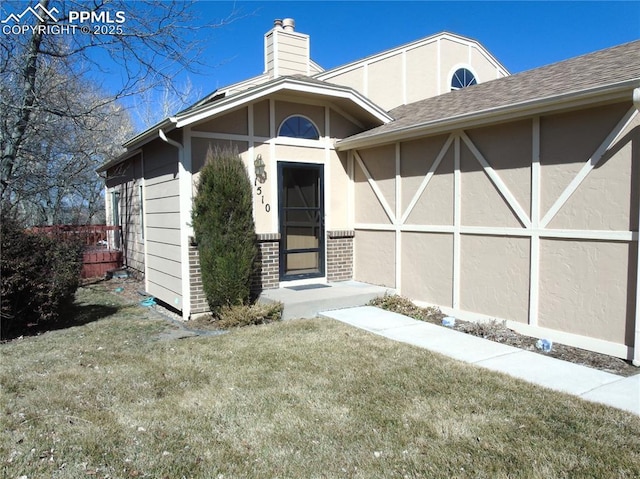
[337,40,640,149]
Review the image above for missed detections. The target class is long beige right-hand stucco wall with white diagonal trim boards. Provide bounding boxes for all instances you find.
[353,102,640,357]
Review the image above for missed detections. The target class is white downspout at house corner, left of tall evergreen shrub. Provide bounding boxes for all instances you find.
[158,128,191,320]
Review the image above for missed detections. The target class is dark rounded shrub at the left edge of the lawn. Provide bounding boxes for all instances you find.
[0,217,83,339]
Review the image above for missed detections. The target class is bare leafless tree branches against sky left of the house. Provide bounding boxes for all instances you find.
[0,0,239,222]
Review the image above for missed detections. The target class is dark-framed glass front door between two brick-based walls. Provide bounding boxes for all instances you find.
[278,163,324,281]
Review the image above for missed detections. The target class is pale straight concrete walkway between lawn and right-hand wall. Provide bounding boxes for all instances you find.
[320,306,640,416]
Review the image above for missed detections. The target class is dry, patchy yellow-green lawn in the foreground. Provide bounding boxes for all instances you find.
[0,286,640,478]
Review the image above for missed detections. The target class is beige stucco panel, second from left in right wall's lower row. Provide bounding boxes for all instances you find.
[401,232,453,306]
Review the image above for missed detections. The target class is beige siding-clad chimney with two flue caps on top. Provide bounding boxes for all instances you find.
[264,18,311,78]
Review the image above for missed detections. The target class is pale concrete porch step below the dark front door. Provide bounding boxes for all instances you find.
[260,281,395,319]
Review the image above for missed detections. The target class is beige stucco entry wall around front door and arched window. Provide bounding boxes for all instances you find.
[186,98,362,240]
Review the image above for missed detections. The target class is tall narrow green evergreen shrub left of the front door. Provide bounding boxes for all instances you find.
[192,148,258,317]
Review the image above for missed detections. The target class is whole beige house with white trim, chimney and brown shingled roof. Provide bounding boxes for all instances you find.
[100,19,640,362]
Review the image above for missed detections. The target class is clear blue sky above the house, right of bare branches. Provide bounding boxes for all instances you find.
[191,1,640,89]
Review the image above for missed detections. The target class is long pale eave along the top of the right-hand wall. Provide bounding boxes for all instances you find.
[335,78,640,151]
